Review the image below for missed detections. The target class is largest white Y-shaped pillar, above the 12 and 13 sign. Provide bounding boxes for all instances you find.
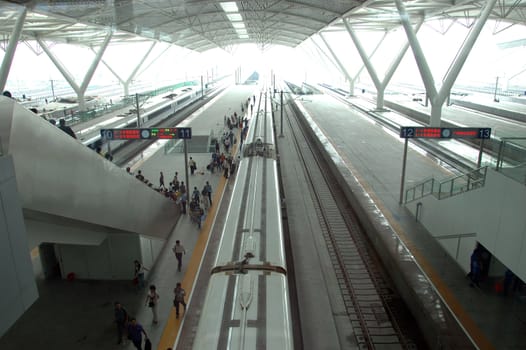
[395,0,497,127]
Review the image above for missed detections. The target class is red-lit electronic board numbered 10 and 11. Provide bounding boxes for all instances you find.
[100,128,192,140]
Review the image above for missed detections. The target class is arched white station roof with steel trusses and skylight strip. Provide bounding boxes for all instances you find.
[0,0,526,52]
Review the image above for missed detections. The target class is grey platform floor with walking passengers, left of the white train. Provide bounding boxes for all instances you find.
[0,86,255,350]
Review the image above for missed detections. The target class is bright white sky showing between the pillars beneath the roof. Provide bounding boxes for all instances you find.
[0,23,526,98]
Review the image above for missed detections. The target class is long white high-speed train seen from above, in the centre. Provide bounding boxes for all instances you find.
[193,93,294,350]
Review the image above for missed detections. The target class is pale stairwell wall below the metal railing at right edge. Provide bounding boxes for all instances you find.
[407,169,526,281]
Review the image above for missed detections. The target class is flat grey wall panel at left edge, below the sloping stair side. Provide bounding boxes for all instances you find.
[0,156,38,336]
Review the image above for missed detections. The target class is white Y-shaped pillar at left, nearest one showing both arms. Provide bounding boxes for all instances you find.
[36,31,112,111]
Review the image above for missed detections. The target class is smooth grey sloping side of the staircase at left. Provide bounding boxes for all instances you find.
[0,96,177,239]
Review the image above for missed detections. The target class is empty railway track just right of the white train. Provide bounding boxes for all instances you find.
[285,94,426,349]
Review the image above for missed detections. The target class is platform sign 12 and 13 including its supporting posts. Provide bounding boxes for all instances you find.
[399,126,491,204]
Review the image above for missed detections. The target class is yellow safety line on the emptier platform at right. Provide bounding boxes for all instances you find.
[360,171,495,350]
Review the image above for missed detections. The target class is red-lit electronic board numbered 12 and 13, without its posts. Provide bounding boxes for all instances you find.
[400,126,491,139]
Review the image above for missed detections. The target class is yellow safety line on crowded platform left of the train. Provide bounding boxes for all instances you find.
[157,131,239,350]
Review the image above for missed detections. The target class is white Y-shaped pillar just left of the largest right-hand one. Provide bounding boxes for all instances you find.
[343,19,423,110]
